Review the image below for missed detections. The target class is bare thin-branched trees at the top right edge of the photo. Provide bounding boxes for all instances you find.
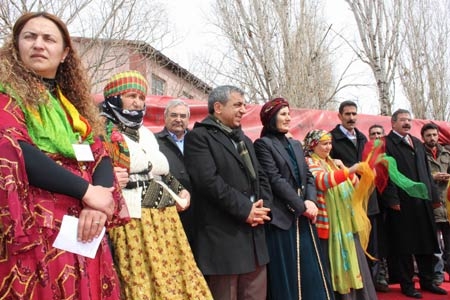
[398,0,450,121]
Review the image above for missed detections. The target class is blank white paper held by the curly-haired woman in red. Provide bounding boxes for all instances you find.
[53,215,105,258]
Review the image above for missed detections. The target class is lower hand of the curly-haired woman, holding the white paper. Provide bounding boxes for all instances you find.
[77,207,107,243]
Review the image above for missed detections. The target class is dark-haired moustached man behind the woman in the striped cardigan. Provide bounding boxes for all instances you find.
[330,100,382,292]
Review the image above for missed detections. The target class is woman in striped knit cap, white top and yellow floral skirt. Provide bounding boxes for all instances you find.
[102,71,212,300]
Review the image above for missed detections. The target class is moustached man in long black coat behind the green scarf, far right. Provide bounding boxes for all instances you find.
[382,109,447,298]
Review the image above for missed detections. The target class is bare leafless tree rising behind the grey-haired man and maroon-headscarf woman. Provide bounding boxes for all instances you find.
[208,0,344,109]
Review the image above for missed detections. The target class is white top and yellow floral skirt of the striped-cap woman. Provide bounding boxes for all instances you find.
[104,127,212,300]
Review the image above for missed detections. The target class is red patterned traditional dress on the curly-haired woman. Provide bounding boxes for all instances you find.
[0,89,127,300]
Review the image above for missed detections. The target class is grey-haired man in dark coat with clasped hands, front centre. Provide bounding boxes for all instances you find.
[184,86,272,300]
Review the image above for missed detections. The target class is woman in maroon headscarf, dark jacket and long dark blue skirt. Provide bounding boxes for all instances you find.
[254,98,334,300]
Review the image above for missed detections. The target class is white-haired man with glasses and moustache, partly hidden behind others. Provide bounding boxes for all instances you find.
[155,99,195,247]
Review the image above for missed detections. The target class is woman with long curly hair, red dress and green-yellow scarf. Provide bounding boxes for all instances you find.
[0,12,127,299]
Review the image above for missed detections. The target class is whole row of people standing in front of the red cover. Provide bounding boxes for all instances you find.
[0,12,450,300]
